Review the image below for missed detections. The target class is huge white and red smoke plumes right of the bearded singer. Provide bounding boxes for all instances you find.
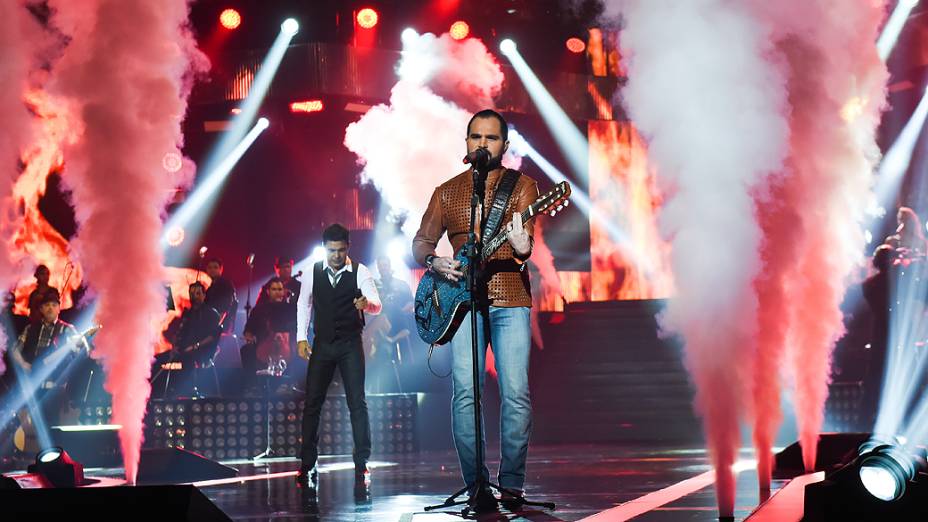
[608,0,886,516]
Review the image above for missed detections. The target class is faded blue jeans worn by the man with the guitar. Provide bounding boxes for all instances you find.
[451,306,532,489]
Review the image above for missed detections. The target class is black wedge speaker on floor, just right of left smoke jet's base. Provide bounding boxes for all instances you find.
[137,448,238,484]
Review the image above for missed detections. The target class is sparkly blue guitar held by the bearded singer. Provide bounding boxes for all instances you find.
[415,181,570,344]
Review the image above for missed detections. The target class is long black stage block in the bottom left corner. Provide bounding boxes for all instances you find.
[0,485,232,522]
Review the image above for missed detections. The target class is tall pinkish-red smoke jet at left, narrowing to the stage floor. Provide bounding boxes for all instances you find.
[48,0,203,483]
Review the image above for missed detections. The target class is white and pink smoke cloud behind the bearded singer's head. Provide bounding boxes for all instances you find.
[345,34,517,241]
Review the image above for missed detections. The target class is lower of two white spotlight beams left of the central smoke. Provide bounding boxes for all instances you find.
[161,118,270,250]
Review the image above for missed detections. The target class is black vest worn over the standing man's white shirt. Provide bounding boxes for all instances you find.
[313,261,363,343]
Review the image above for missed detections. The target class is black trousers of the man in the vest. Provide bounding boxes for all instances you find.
[300,335,371,469]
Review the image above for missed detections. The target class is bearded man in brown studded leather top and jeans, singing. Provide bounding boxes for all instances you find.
[412,110,538,511]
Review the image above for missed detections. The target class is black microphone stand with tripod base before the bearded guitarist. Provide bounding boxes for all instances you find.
[425,160,555,518]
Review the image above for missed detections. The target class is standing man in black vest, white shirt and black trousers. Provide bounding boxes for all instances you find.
[297,223,380,494]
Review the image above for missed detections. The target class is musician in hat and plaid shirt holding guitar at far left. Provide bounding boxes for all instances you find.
[11,288,88,380]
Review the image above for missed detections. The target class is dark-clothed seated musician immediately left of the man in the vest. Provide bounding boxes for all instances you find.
[241,277,296,387]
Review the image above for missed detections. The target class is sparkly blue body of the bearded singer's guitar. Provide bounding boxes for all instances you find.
[415,248,470,344]
